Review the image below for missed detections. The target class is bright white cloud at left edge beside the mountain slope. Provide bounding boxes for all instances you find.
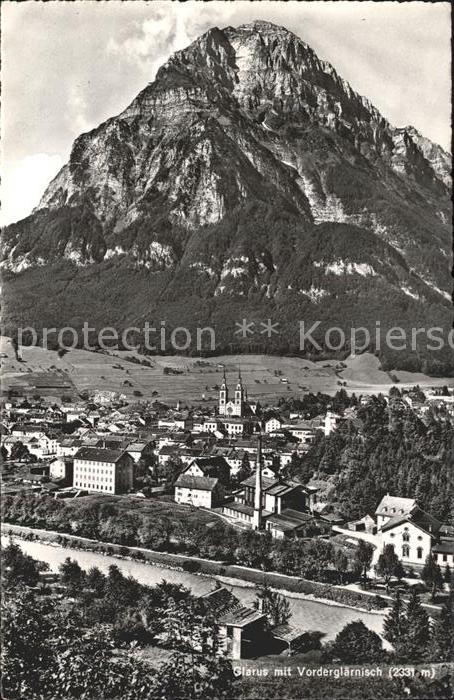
[0,153,63,226]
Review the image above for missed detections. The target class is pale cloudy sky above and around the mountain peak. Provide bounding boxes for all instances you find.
[0,0,451,225]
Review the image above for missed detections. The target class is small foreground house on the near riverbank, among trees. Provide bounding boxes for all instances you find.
[200,587,267,659]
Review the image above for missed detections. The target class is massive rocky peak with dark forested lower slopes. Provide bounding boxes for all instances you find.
[1,21,454,373]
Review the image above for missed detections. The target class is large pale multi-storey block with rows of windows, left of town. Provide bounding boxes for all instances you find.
[73,447,134,494]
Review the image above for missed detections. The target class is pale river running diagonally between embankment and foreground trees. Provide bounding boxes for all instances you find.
[2,536,383,641]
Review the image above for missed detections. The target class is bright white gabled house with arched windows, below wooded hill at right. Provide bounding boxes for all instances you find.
[379,506,443,566]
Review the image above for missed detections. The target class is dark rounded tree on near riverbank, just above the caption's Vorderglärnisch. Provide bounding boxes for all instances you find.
[329,620,384,664]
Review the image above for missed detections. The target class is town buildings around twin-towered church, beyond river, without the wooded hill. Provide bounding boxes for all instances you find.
[1,370,454,569]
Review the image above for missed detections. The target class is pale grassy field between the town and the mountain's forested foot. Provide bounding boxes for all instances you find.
[0,339,454,405]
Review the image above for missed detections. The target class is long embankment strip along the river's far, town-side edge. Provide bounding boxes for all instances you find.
[1,523,389,614]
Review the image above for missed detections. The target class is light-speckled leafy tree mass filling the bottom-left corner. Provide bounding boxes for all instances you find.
[2,590,155,700]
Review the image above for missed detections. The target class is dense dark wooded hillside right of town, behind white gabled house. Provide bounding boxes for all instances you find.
[291,390,454,524]
